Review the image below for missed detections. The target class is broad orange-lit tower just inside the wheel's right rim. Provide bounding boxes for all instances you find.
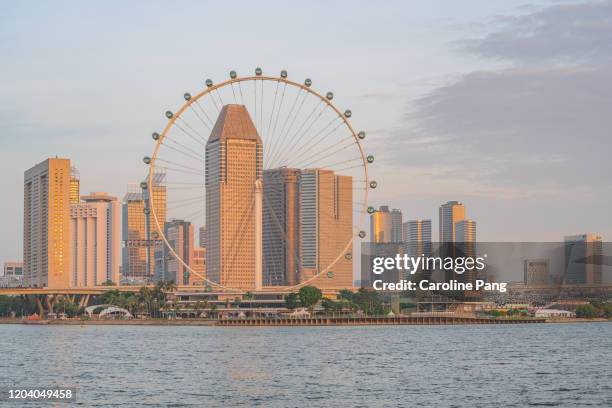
[299,169,353,289]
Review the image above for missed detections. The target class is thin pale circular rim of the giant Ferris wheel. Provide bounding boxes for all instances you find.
[147,71,370,292]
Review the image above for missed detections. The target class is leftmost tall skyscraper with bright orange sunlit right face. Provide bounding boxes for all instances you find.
[23,158,71,288]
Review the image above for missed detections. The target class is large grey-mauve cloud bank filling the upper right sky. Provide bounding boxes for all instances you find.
[387,1,612,197]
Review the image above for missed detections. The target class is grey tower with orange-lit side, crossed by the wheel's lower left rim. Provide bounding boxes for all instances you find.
[155,220,194,285]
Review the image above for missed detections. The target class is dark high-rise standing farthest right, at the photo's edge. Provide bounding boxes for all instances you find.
[563,233,603,285]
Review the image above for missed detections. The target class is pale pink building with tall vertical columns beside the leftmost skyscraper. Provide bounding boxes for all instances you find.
[70,193,121,287]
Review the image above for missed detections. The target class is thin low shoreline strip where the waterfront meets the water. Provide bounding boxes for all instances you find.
[0,317,611,327]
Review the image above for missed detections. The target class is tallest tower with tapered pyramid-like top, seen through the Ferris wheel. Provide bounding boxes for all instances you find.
[205,105,263,290]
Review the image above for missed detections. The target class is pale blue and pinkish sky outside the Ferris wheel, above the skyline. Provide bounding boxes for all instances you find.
[0,0,612,261]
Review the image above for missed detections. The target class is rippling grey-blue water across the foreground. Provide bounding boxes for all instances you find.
[0,323,612,407]
